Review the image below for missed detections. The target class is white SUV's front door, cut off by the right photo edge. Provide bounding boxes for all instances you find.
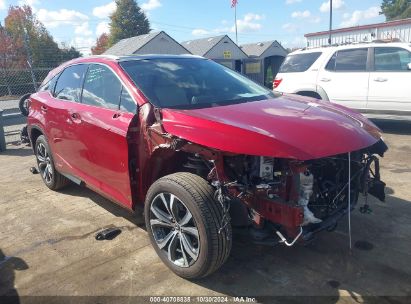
[367,47,411,114]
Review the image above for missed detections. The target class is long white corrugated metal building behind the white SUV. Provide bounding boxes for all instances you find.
[304,18,411,47]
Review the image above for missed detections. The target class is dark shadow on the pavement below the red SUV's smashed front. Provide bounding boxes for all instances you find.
[192,196,411,303]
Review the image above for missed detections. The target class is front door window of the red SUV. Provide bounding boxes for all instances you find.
[82,64,122,110]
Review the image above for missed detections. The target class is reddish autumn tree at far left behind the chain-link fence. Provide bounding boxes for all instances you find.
[5,5,80,67]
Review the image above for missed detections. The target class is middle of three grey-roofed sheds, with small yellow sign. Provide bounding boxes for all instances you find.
[181,35,248,72]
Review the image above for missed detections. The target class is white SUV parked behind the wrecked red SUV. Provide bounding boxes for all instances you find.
[274,43,411,120]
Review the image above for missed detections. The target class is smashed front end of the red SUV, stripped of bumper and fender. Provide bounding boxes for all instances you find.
[138,100,387,246]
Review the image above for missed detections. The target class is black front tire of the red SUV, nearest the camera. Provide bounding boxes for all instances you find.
[144,173,232,279]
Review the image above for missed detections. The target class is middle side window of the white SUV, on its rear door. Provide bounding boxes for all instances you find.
[334,48,368,72]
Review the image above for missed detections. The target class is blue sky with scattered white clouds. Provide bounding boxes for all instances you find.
[0,0,385,54]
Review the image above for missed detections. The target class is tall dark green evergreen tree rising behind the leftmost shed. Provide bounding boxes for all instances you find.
[109,0,151,46]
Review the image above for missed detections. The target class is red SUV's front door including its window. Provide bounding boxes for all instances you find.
[71,64,137,208]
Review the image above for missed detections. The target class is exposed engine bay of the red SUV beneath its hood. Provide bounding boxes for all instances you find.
[181,141,387,246]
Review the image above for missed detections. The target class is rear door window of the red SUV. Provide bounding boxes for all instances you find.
[54,64,87,102]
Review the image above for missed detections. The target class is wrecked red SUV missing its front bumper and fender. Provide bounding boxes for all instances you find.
[28,55,387,278]
